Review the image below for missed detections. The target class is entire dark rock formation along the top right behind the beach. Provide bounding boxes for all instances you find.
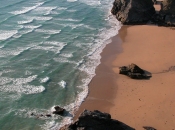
[111,0,175,26]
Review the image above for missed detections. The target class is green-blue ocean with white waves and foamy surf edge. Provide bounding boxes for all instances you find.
[0,0,121,130]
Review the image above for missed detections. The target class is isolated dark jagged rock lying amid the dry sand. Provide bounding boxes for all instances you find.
[119,63,152,79]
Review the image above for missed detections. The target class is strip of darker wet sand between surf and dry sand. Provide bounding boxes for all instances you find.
[73,28,125,121]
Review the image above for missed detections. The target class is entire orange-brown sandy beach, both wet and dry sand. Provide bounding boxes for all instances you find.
[75,25,175,130]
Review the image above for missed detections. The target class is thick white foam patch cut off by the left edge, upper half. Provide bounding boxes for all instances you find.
[0,30,18,41]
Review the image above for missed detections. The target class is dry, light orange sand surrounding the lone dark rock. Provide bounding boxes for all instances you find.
[110,25,175,130]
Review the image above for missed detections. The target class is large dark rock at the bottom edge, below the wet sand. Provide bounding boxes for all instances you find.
[60,110,135,130]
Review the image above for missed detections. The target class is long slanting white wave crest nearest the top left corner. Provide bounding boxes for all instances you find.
[11,2,44,15]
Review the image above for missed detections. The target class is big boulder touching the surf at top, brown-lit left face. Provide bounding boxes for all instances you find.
[111,0,155,24]
